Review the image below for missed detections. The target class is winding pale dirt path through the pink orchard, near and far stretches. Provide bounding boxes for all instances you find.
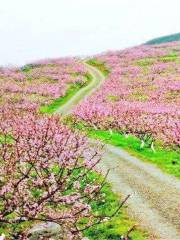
[58,64,180,240]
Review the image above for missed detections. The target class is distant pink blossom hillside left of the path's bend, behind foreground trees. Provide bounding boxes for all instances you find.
[0,59,87,114]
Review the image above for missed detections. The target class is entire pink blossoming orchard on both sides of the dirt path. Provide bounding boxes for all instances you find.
[0,42,180,240]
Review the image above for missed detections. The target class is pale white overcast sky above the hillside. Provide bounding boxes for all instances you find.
[0,0,180,65]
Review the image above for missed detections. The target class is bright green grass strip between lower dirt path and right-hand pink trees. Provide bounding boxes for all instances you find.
[67,119,180,178]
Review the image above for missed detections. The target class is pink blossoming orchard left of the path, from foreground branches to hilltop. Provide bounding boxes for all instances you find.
[0,59,116,240]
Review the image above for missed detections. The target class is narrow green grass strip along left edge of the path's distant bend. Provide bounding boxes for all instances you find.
[40,74,92,114]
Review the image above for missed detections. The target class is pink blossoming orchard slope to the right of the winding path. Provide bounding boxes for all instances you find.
[74,42,180,149]
